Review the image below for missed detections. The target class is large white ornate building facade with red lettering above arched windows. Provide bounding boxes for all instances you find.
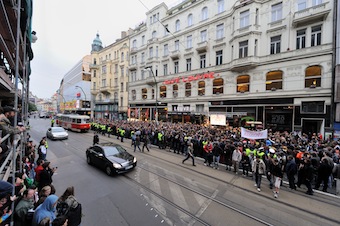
[129,0,333,134]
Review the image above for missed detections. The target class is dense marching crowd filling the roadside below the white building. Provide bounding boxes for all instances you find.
[91,119,340,198]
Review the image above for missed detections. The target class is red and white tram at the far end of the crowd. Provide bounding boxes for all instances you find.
[56,114,90,132]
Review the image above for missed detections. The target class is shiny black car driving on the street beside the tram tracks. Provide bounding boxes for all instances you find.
[86,143,137,176]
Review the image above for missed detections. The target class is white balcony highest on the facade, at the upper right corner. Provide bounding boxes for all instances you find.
[292,1,331,27]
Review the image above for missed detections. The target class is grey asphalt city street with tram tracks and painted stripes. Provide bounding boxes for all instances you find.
[29,118,340,226]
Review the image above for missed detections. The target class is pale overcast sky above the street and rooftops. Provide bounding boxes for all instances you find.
[30,0,181,98]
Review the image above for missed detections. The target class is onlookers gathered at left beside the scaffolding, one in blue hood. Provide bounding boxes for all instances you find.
[0,107,82,226]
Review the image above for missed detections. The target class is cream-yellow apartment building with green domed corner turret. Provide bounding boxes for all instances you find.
[90,31,130,120]
